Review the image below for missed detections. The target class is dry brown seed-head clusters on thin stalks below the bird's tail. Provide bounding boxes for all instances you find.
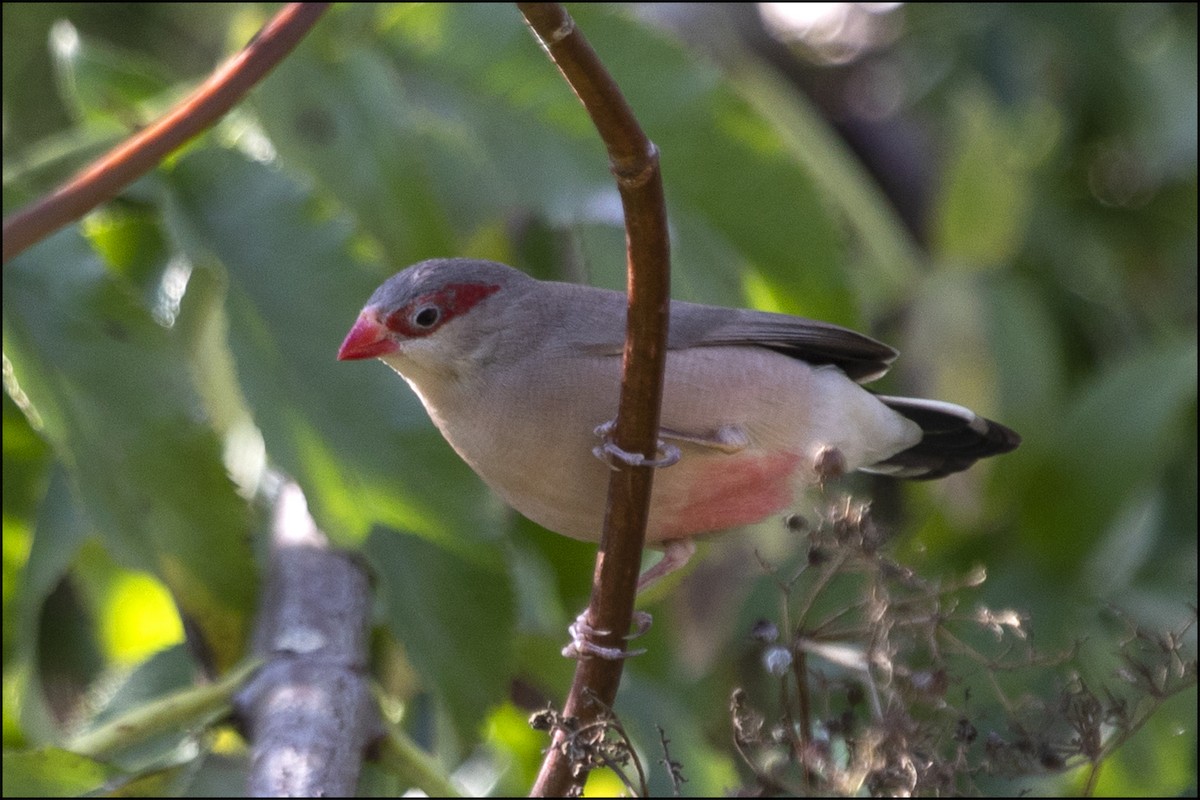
[532,498,1196,796]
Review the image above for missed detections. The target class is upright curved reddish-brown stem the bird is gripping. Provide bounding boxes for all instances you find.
[517,2,670,796]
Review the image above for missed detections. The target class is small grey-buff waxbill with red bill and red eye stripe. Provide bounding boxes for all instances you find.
[337,258,1020,587]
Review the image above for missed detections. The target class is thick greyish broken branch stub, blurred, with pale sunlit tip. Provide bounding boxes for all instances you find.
[234,481,383,798]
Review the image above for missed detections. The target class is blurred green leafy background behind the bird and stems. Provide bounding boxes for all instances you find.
[2,4,1198,795]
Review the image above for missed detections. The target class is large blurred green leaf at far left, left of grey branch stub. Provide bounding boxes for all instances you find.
[4,231,256,667]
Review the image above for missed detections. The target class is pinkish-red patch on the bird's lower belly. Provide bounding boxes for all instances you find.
[648,452,800,541]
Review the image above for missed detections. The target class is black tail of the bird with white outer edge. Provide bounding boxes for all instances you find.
[863,395,1021,480]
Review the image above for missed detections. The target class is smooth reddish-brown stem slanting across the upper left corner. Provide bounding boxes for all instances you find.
[4,2,330,264]
